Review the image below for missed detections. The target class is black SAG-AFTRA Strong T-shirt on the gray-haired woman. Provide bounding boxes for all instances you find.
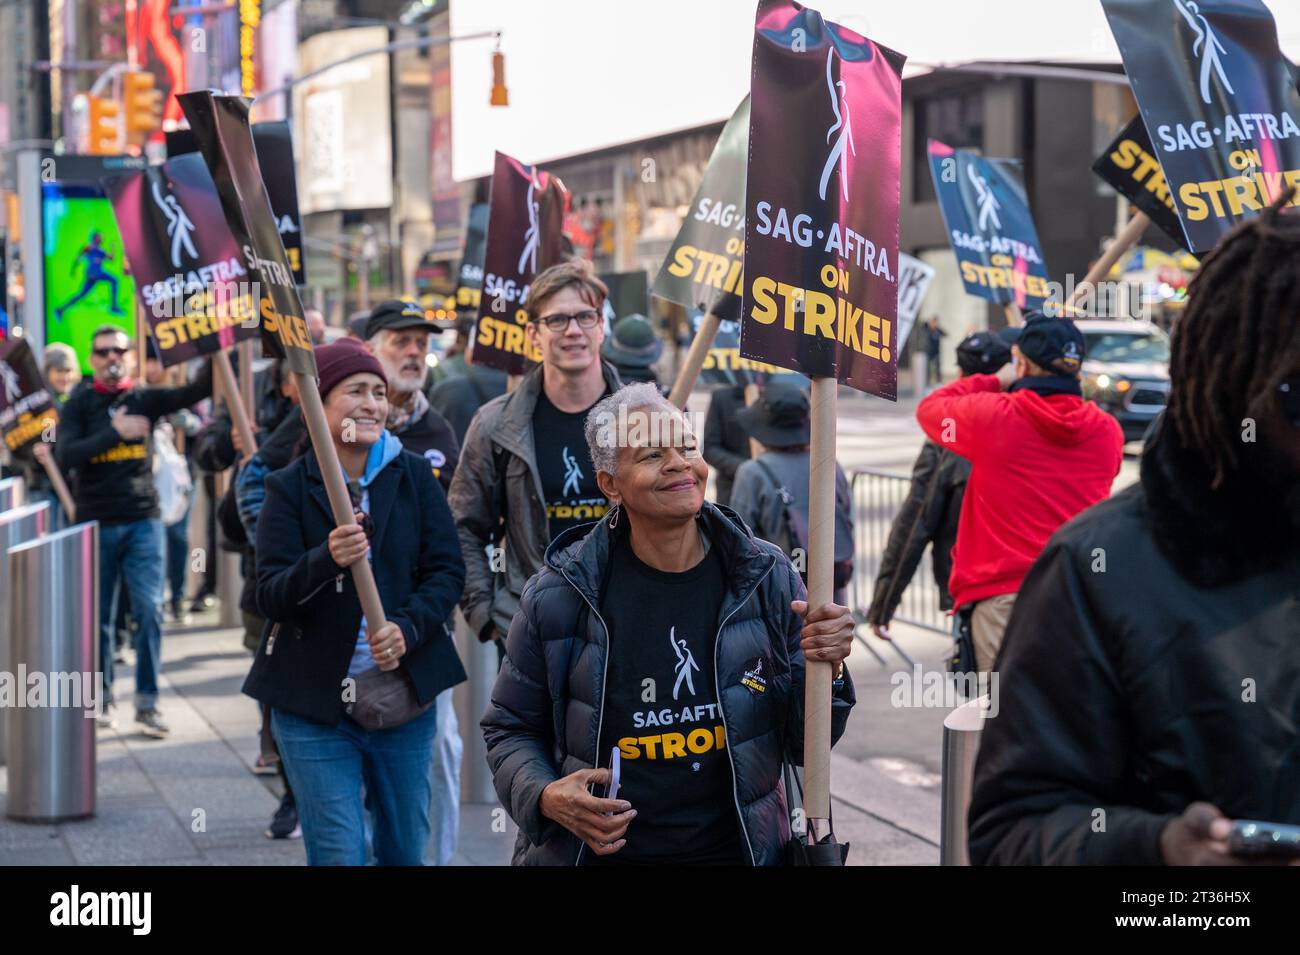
[582,534,745,865]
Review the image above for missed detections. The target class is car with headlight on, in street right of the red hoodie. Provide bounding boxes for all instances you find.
[1076,320,1169,442]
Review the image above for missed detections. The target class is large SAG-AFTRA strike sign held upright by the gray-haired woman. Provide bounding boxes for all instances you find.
[740,0,904,400]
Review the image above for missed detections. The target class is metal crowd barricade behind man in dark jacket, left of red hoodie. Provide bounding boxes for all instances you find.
[852,468,952,634]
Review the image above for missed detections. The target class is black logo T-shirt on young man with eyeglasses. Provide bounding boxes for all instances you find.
[533,390,610,541]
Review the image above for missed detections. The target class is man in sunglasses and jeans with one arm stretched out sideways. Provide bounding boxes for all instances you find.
[55,325,212,739]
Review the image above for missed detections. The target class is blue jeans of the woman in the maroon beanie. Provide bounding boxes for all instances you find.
[270,707,438,865]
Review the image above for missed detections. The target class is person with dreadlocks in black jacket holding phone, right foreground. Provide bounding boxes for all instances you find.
[970,196,1300,865]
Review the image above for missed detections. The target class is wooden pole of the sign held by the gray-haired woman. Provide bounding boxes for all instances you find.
[803,378,839,835]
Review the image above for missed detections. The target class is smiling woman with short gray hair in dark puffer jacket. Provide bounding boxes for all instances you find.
[482,383,854,865]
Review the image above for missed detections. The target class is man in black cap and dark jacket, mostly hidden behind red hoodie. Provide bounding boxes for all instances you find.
[867,327,1018,639]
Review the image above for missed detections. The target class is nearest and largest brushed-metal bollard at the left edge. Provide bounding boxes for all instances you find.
[7,521,98,822]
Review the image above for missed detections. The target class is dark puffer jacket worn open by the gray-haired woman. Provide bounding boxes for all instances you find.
[482,503,855,865]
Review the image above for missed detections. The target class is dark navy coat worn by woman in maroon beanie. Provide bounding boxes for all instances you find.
[243,451,465,726]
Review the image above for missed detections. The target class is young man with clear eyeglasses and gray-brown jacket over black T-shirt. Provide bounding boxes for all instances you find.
[449,260,621,652]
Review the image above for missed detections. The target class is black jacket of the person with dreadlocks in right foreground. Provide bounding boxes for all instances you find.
[970,426,1300,865]
